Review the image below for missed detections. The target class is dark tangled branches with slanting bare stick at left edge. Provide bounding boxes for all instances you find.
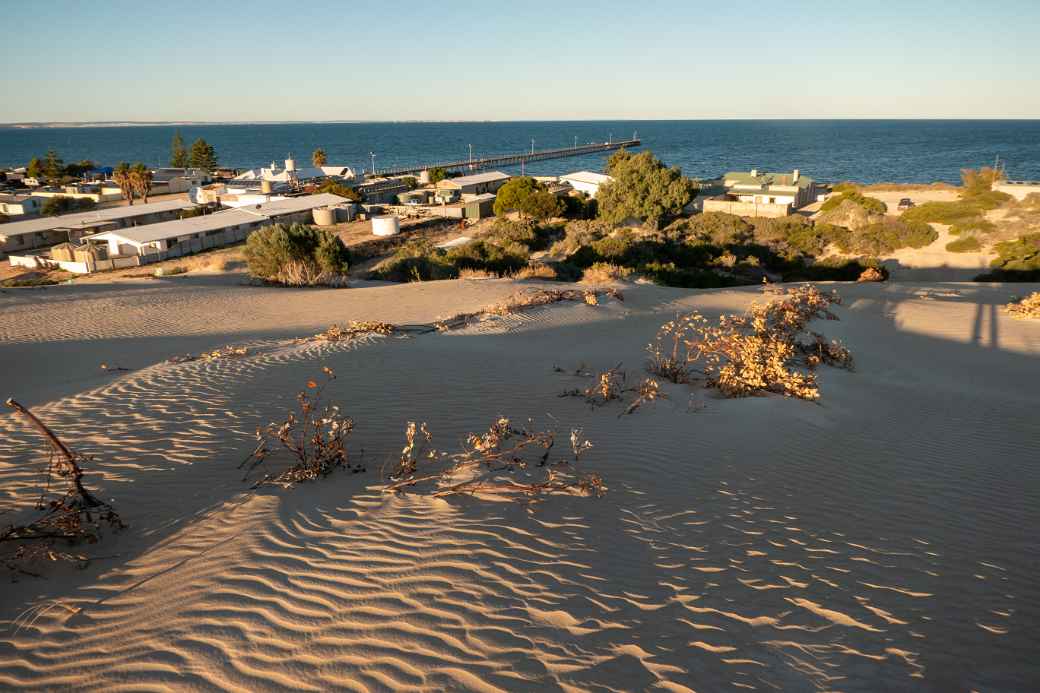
[0,399,126,574]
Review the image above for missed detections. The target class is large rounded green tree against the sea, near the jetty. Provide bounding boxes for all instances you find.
[596,149,697,228]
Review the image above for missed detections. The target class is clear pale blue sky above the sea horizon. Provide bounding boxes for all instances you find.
[0,0,1040,122]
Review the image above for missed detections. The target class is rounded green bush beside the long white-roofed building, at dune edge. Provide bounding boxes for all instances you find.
[245,224,350,286]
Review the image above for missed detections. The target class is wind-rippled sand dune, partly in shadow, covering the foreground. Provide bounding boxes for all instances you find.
[0,277,1040,691]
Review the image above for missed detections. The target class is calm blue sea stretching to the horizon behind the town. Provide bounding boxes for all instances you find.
[0,121,1040,182]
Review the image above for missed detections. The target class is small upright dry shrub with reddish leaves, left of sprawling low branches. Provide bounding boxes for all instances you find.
[239,367,365,486]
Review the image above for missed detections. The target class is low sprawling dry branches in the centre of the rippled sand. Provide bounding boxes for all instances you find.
[384,417,606,502]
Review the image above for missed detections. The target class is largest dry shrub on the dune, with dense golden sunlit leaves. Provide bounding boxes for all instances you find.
[647,286,853,400]
